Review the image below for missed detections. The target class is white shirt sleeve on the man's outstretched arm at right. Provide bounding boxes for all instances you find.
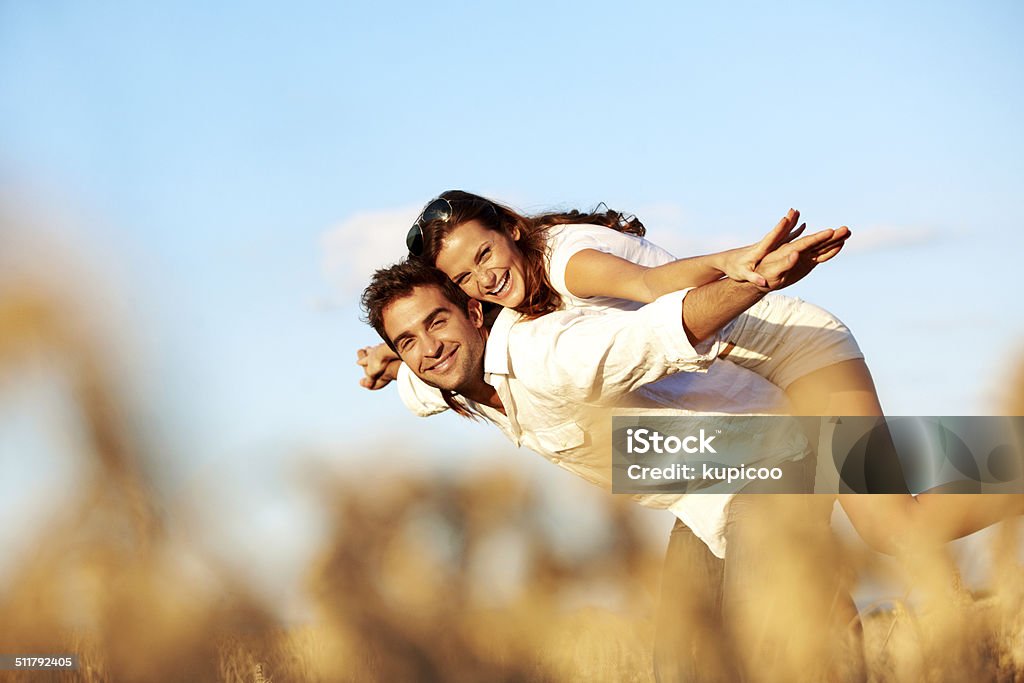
[510,290,722,403]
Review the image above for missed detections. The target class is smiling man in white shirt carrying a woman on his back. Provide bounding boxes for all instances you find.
[362,230,864,680]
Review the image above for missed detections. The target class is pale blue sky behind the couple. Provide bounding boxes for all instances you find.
[0,2,1024,610]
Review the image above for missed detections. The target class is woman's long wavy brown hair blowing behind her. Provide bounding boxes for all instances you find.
[421,189,646,318]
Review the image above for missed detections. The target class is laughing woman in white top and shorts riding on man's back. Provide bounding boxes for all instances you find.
[358,190,1022,552]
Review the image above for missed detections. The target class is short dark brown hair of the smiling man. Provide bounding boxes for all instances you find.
[360,258,469,352]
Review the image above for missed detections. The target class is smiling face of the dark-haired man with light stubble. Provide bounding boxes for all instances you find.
[383,287,484,391]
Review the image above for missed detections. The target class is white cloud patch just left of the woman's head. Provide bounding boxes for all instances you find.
[321,207,419,297]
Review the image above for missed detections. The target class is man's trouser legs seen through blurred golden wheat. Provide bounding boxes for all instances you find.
[654,459,864,683]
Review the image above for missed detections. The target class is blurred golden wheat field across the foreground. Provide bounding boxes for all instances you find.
[0,228,1024,683]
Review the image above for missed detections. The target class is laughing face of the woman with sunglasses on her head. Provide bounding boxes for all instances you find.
[436,220,526,308]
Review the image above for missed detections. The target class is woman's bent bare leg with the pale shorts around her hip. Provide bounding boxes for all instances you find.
[723,295,1024,552]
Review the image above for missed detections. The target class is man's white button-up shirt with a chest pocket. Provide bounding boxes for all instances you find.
[398,290,804,557]
